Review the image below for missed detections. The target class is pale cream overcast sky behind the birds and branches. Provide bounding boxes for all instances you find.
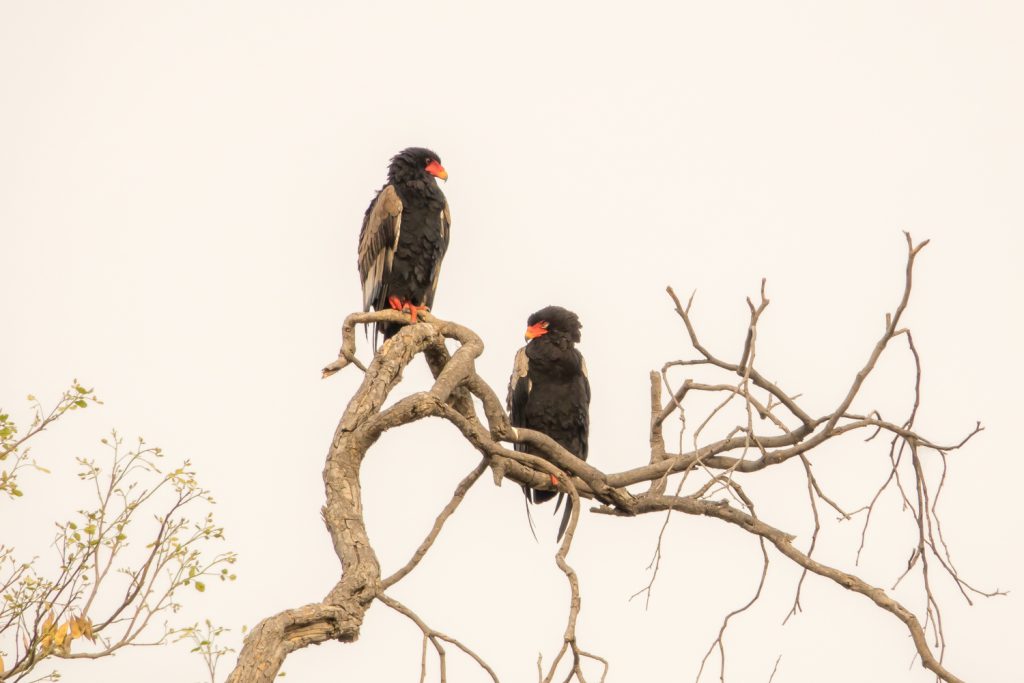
[0,0,1024,683]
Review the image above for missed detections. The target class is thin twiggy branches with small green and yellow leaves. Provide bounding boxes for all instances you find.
[0,382,237,683]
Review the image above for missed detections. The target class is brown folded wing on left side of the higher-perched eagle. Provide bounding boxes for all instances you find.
[358,185,402,310]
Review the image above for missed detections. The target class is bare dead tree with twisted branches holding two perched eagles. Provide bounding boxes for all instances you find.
[228,234,998,683]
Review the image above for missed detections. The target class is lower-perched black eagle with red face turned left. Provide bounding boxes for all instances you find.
[508,306,590,541]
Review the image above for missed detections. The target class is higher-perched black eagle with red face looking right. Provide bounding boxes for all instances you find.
[358,147,452,344]
